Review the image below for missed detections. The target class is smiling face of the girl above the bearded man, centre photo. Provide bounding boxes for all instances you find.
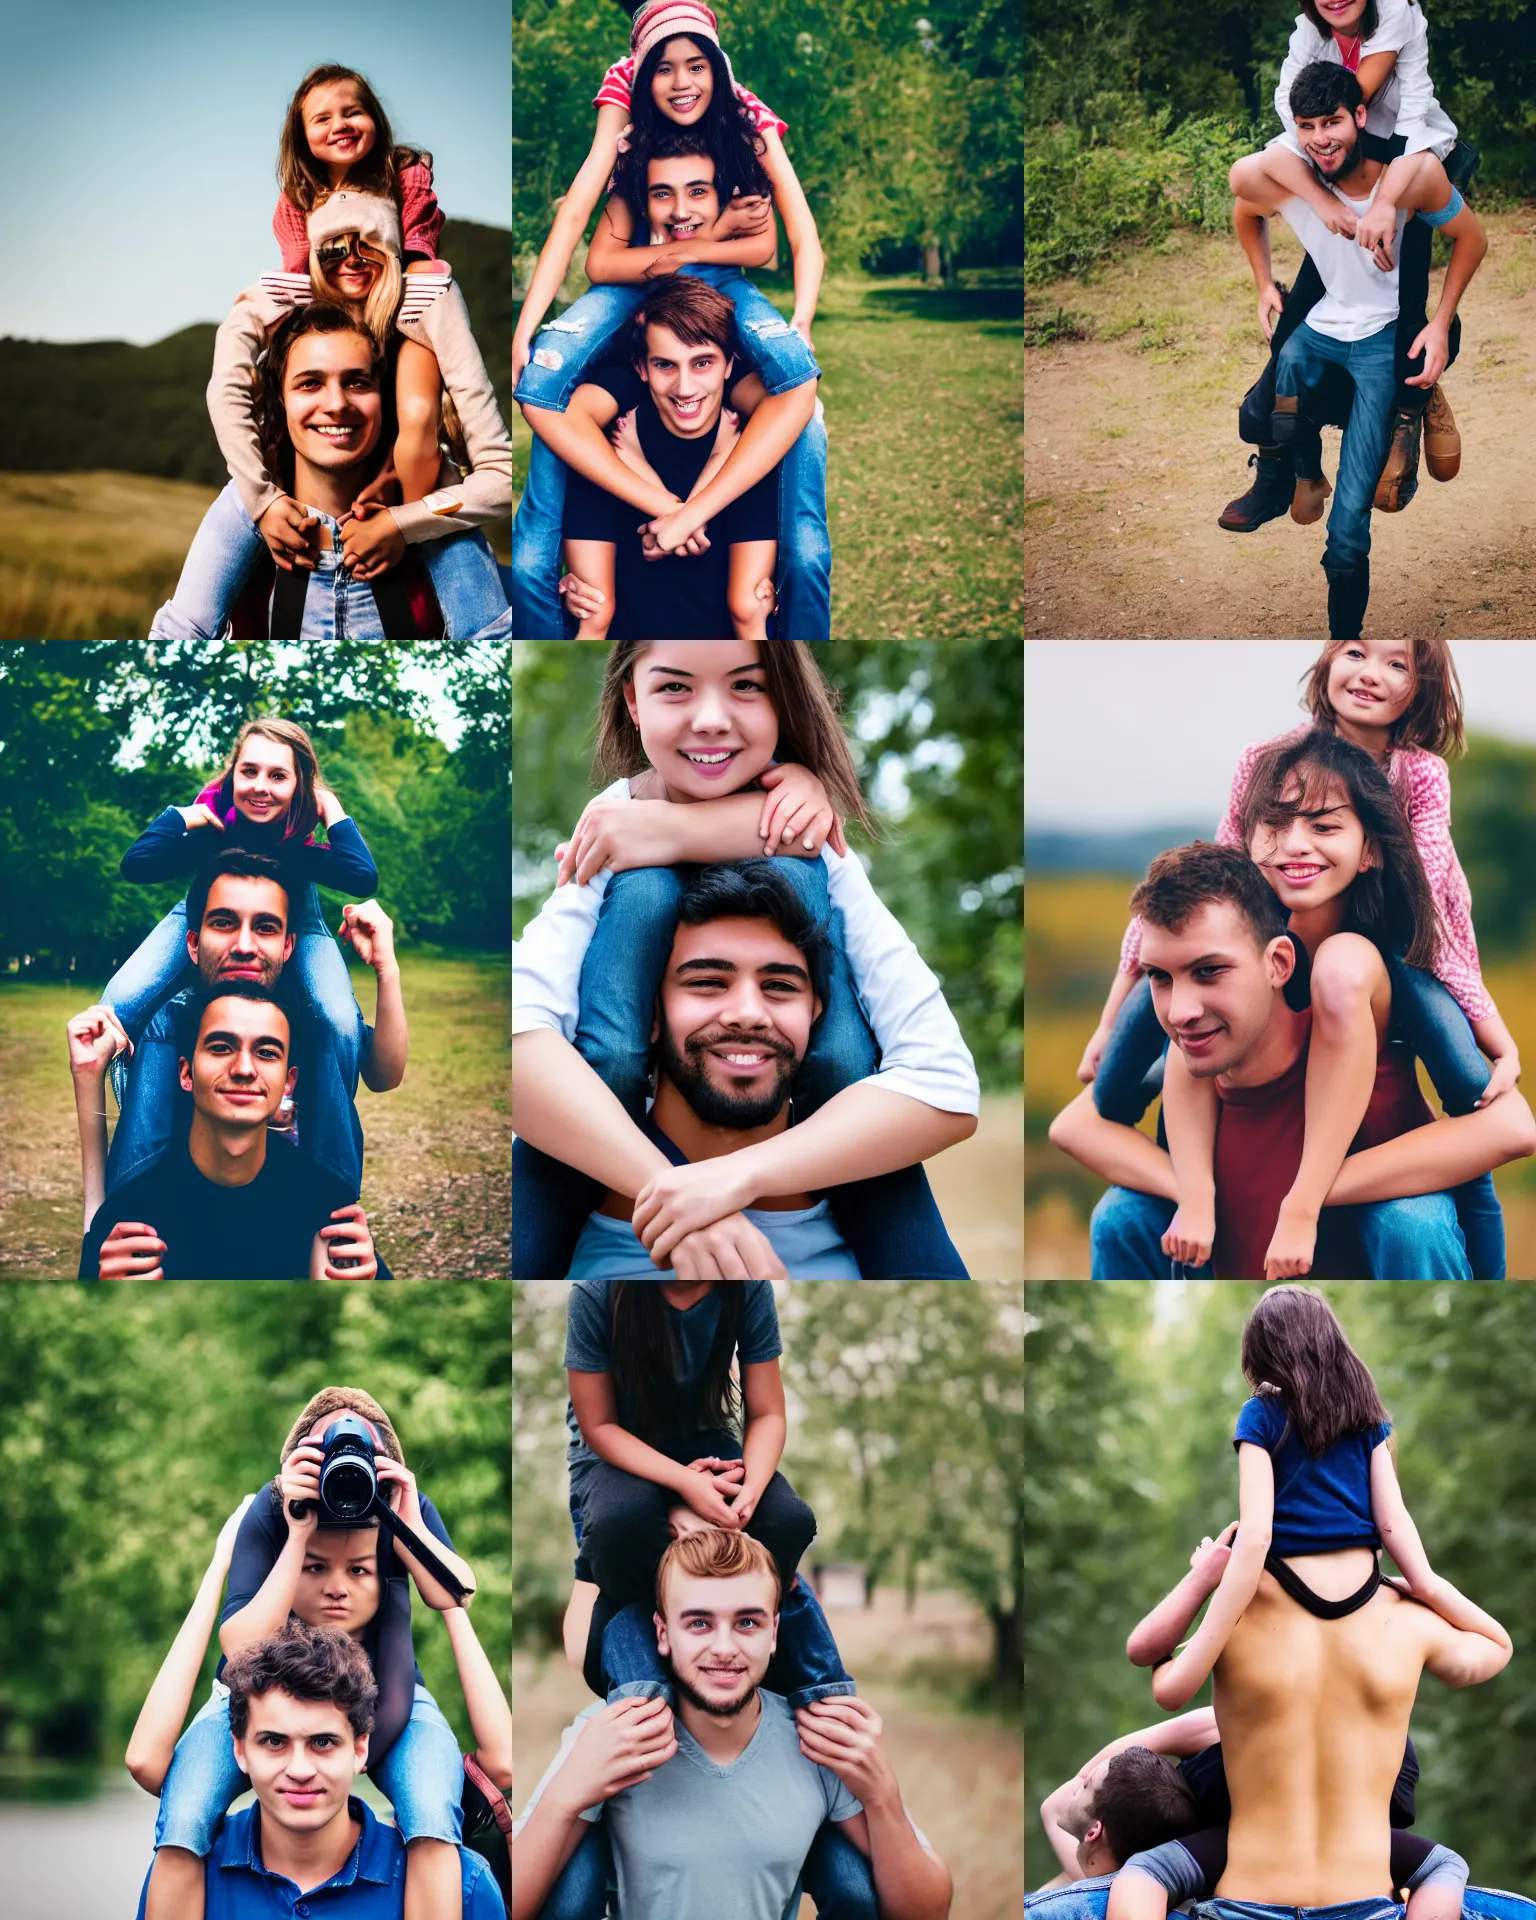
[624,639,780,801]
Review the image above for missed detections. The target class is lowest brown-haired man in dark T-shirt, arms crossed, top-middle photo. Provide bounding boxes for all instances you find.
[524,274,802,639]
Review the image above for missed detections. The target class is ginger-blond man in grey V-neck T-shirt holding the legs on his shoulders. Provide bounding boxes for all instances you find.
[513,1530,950,1920]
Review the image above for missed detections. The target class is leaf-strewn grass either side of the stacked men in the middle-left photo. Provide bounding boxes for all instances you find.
[0,950,511,1281]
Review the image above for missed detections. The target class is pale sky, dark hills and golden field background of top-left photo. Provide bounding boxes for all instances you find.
[0,0,513,639]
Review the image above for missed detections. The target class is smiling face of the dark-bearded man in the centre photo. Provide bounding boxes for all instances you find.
[653,920,822,1129]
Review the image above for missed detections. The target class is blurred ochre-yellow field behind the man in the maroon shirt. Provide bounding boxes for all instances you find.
[1023,874,1536,1281]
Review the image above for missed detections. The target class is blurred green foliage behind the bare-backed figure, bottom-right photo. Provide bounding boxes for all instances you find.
[1025,1281,1536,1895]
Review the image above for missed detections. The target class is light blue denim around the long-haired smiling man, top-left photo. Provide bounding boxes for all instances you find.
[150,480,507,639]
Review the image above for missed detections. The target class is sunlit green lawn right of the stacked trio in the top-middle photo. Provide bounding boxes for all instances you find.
[513,276,1023,639]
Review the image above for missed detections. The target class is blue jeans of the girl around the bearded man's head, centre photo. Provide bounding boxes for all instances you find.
[513,856,968,1281]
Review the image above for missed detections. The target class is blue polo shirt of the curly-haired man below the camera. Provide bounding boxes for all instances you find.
[138,1799,507,1920]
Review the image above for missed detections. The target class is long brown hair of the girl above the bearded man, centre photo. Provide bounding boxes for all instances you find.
[591,639,879,835]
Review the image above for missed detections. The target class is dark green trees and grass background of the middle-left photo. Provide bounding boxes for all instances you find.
[0,641,511,1279]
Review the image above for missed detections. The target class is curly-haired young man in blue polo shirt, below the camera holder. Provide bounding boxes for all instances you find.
[138,1620,507,1920]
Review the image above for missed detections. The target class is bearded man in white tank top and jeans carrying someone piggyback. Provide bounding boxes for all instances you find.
[1221,61,1488,639]
